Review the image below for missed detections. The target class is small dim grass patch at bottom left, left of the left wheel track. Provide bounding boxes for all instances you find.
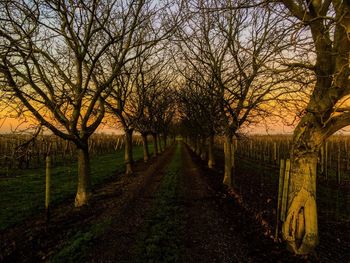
[50,218,112,263]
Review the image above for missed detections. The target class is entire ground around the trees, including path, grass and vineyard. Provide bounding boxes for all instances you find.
[0,136,350,262]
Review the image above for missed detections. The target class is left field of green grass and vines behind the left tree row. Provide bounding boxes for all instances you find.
[0,135,153,230]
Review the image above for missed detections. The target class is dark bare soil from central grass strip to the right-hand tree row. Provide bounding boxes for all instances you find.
[182,145,319,263]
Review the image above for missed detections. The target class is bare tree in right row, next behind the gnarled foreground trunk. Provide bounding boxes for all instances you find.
[177,0,292,187]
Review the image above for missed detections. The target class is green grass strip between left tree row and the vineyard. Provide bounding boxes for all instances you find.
[0,145,153,230]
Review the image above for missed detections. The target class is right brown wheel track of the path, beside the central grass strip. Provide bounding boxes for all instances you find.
[181,146,251,262]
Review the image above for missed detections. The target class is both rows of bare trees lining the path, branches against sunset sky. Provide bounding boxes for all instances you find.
[0,0,350,254]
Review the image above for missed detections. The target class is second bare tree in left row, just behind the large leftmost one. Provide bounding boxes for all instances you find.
[106,0,178,174]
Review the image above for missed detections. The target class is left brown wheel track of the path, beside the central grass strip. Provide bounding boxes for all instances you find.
[86,146,175,262]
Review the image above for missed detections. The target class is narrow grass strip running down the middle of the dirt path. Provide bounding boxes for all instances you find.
[133,144,182,262]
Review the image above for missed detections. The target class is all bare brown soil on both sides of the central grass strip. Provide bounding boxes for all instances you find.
[0,144,346,262]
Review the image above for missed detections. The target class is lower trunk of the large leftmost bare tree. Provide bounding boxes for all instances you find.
[75,143,91,207]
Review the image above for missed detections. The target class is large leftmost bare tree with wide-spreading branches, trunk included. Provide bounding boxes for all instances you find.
[0,0,154,206]
